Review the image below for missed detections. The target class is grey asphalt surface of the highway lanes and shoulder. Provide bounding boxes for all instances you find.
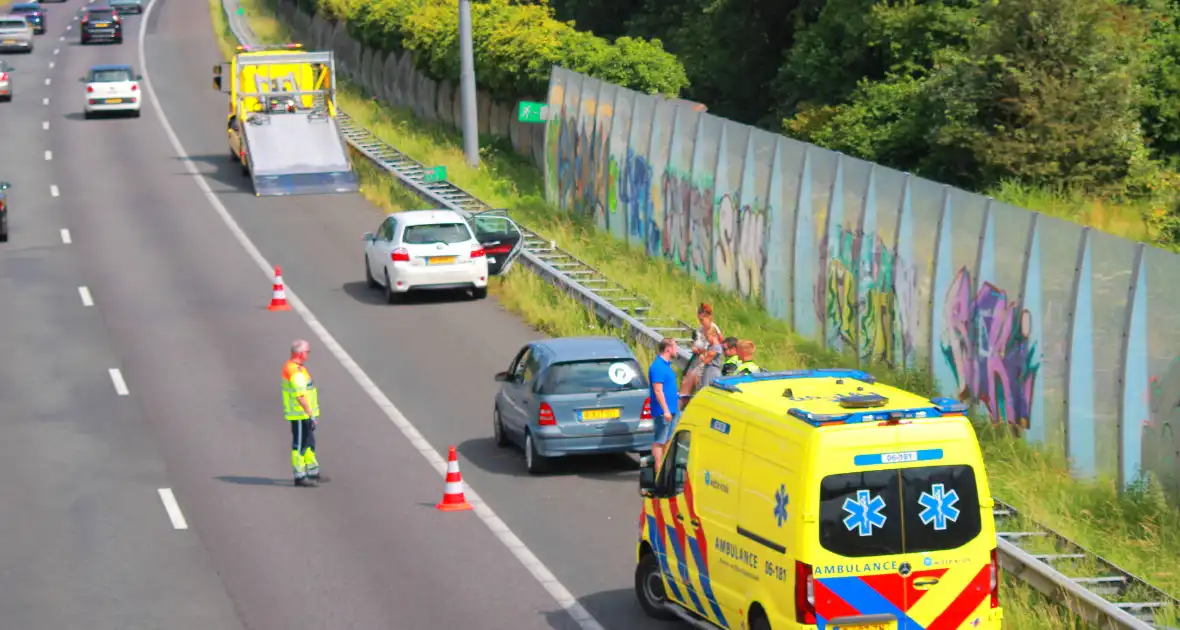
[0,0,684,630]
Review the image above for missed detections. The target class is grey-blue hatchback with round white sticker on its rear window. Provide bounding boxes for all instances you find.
[492,336,654,474]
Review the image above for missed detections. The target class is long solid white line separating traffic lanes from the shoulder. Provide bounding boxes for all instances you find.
[138,0,603,630]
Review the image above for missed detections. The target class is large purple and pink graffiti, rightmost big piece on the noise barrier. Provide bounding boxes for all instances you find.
[940,268,1041,428]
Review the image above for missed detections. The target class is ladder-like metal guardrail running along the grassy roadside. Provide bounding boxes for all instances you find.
[222,0,1180,630]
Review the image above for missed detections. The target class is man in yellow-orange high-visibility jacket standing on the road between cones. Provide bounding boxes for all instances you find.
[283,339,320,486]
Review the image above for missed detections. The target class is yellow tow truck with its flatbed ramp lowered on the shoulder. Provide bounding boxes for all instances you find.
[214,44,360,197]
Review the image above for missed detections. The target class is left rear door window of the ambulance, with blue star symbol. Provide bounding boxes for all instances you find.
[819,471,904,558]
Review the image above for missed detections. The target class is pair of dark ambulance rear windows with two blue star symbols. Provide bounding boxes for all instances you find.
[819,466,982,558]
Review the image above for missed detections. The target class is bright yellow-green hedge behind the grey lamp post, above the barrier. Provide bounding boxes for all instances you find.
[300,0,688,101]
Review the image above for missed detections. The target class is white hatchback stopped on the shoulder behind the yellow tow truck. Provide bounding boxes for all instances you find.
[365,210,489,303]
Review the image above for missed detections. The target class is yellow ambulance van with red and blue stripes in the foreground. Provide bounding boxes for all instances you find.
[635,369,1003,630]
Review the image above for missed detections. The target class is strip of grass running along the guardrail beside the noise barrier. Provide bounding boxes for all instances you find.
[210,0,1180,629]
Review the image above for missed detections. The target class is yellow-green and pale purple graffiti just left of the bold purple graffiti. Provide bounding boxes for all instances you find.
[815,227,918,366]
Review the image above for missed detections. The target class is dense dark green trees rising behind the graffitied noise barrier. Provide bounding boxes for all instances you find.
[550,0,1180,236]
